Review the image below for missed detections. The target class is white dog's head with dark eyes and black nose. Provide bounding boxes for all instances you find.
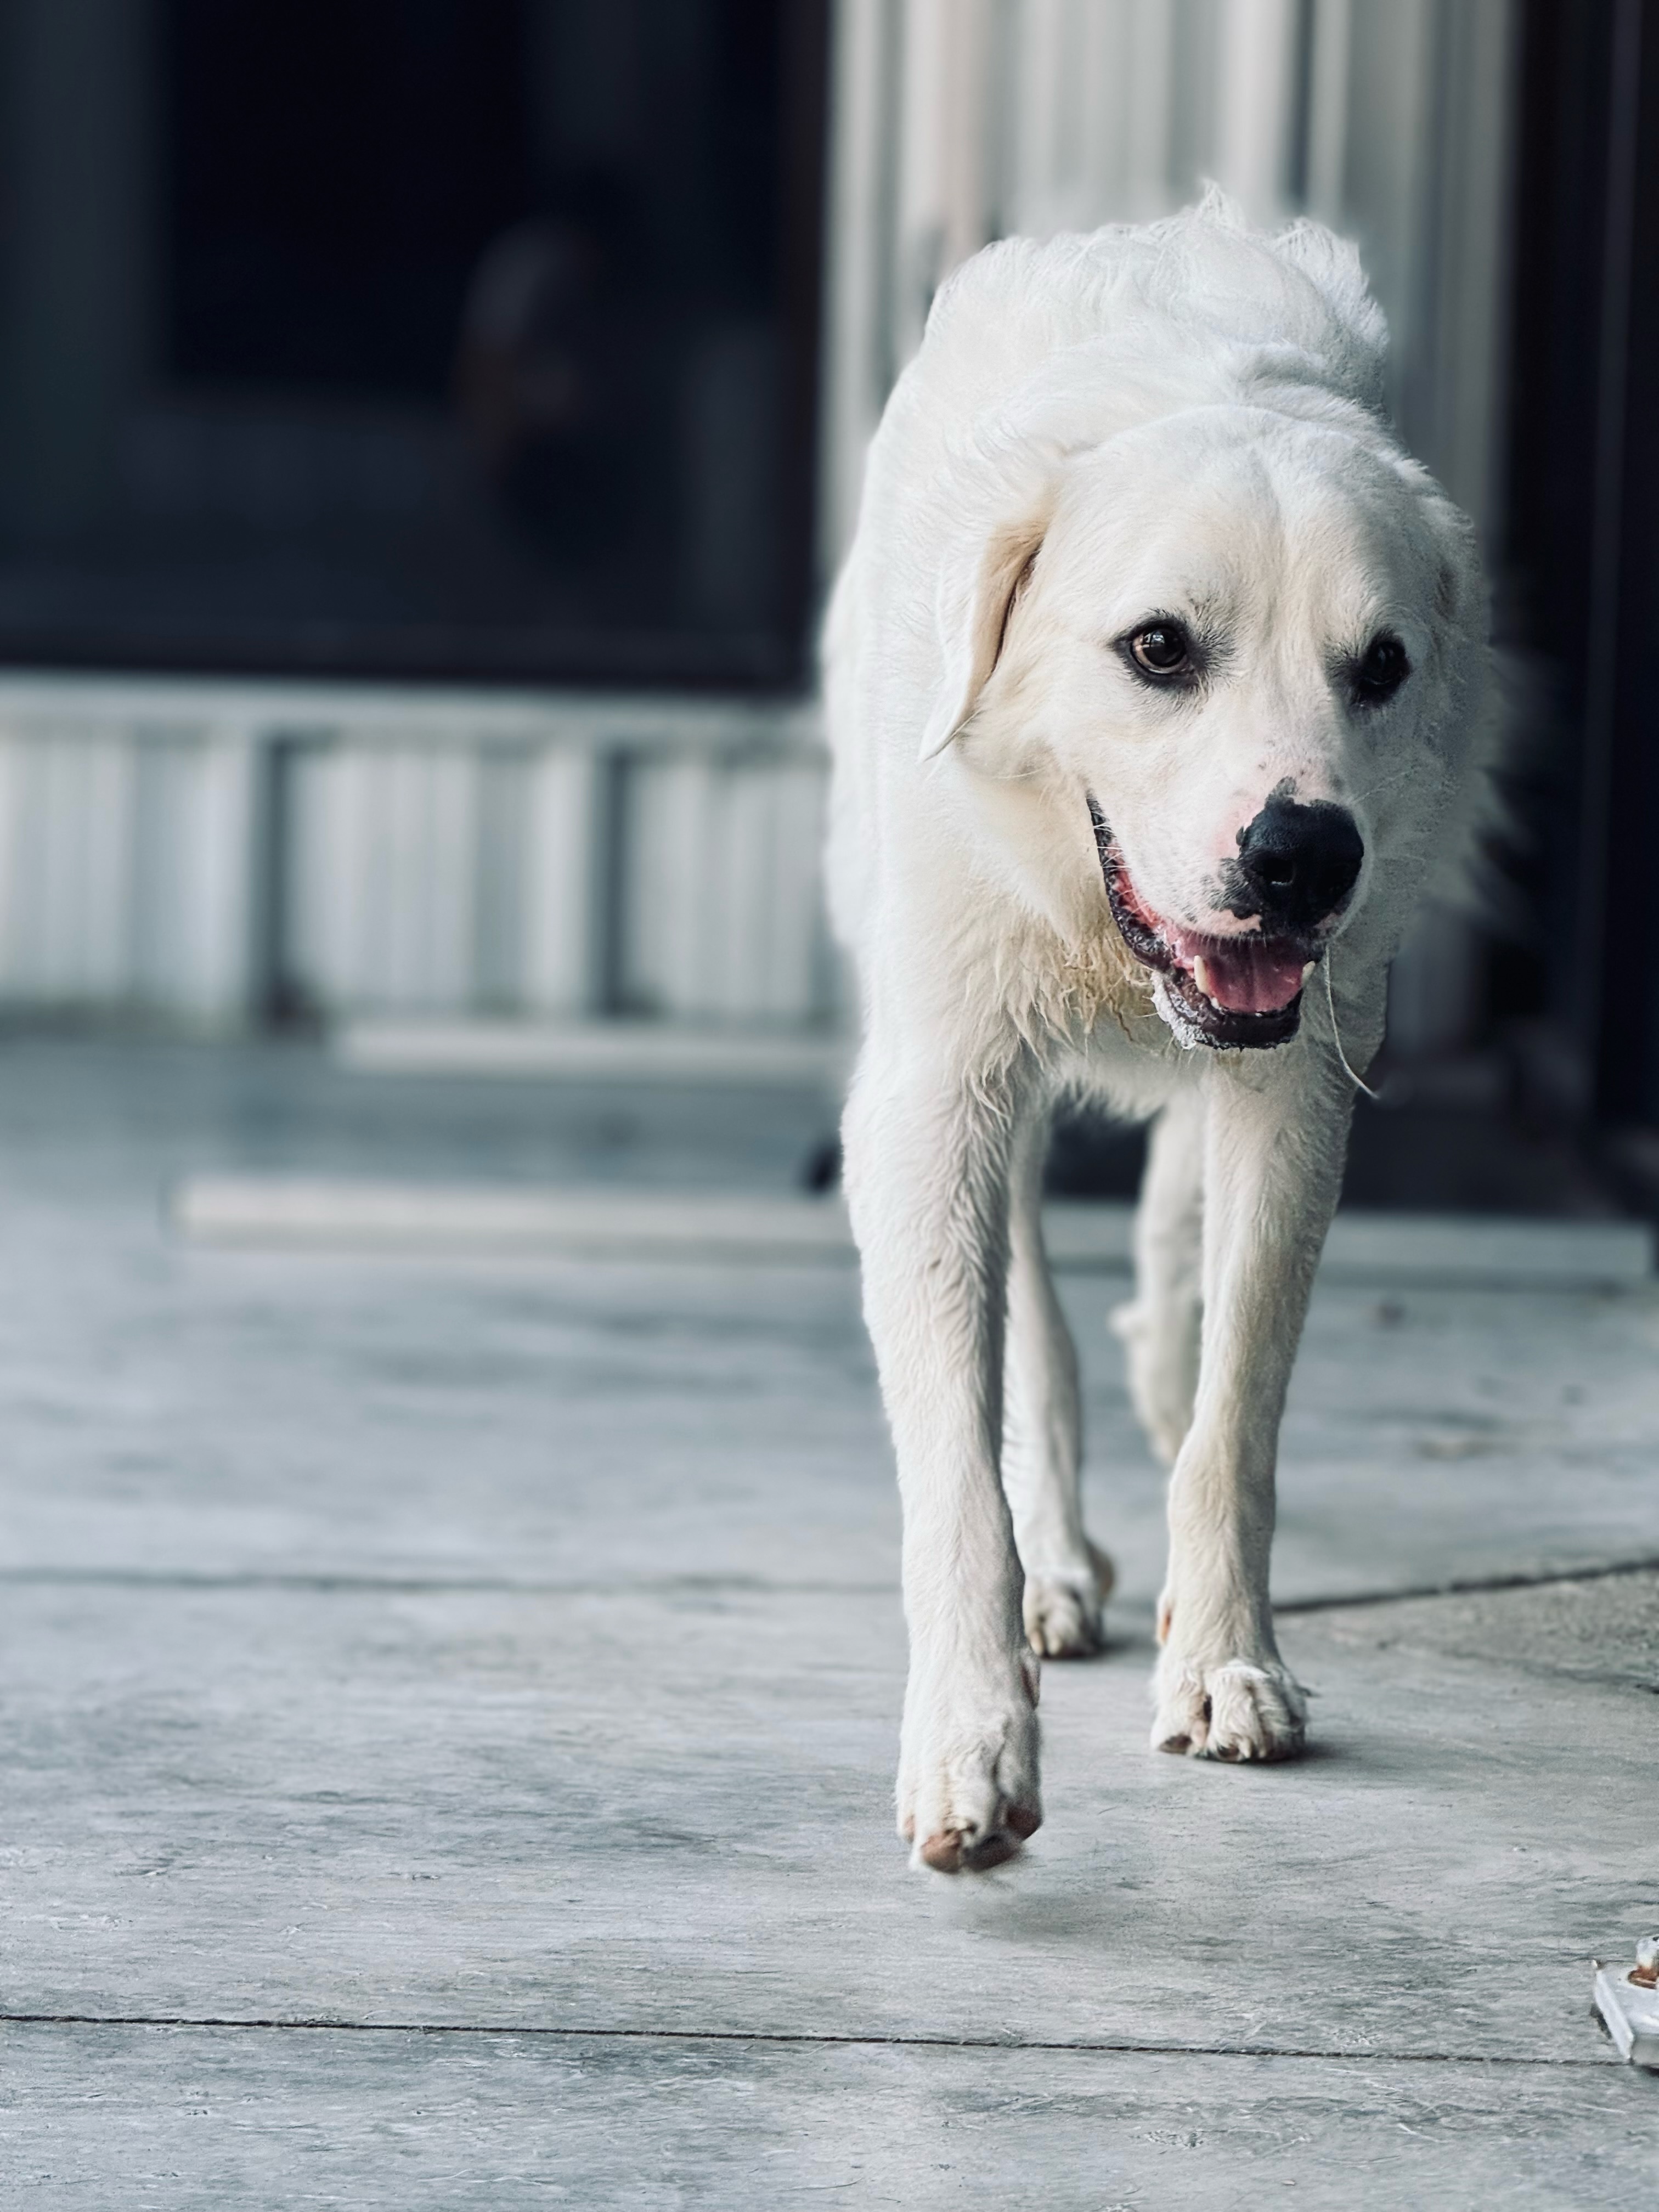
[924,405,1484,1046]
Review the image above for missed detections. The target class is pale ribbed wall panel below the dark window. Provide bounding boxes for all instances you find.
[0,675,836,1029]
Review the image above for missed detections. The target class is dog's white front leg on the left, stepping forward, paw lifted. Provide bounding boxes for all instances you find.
[845,1040,1042,1874]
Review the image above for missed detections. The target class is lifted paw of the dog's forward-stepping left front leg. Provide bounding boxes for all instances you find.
[898,1652,1042,1874]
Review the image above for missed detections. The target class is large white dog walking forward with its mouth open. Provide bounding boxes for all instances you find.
[825,193,1489,1871]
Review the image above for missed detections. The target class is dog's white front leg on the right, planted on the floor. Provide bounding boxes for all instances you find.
[1153,1046,1352,1758]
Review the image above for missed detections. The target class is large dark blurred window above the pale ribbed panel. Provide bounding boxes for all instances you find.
[0,0,823,684]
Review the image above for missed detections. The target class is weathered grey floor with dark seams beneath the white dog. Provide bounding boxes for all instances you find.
[0,1042,1659,2212]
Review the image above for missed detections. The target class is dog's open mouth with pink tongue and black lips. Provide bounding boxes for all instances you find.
[1088,799,1318,1051]
